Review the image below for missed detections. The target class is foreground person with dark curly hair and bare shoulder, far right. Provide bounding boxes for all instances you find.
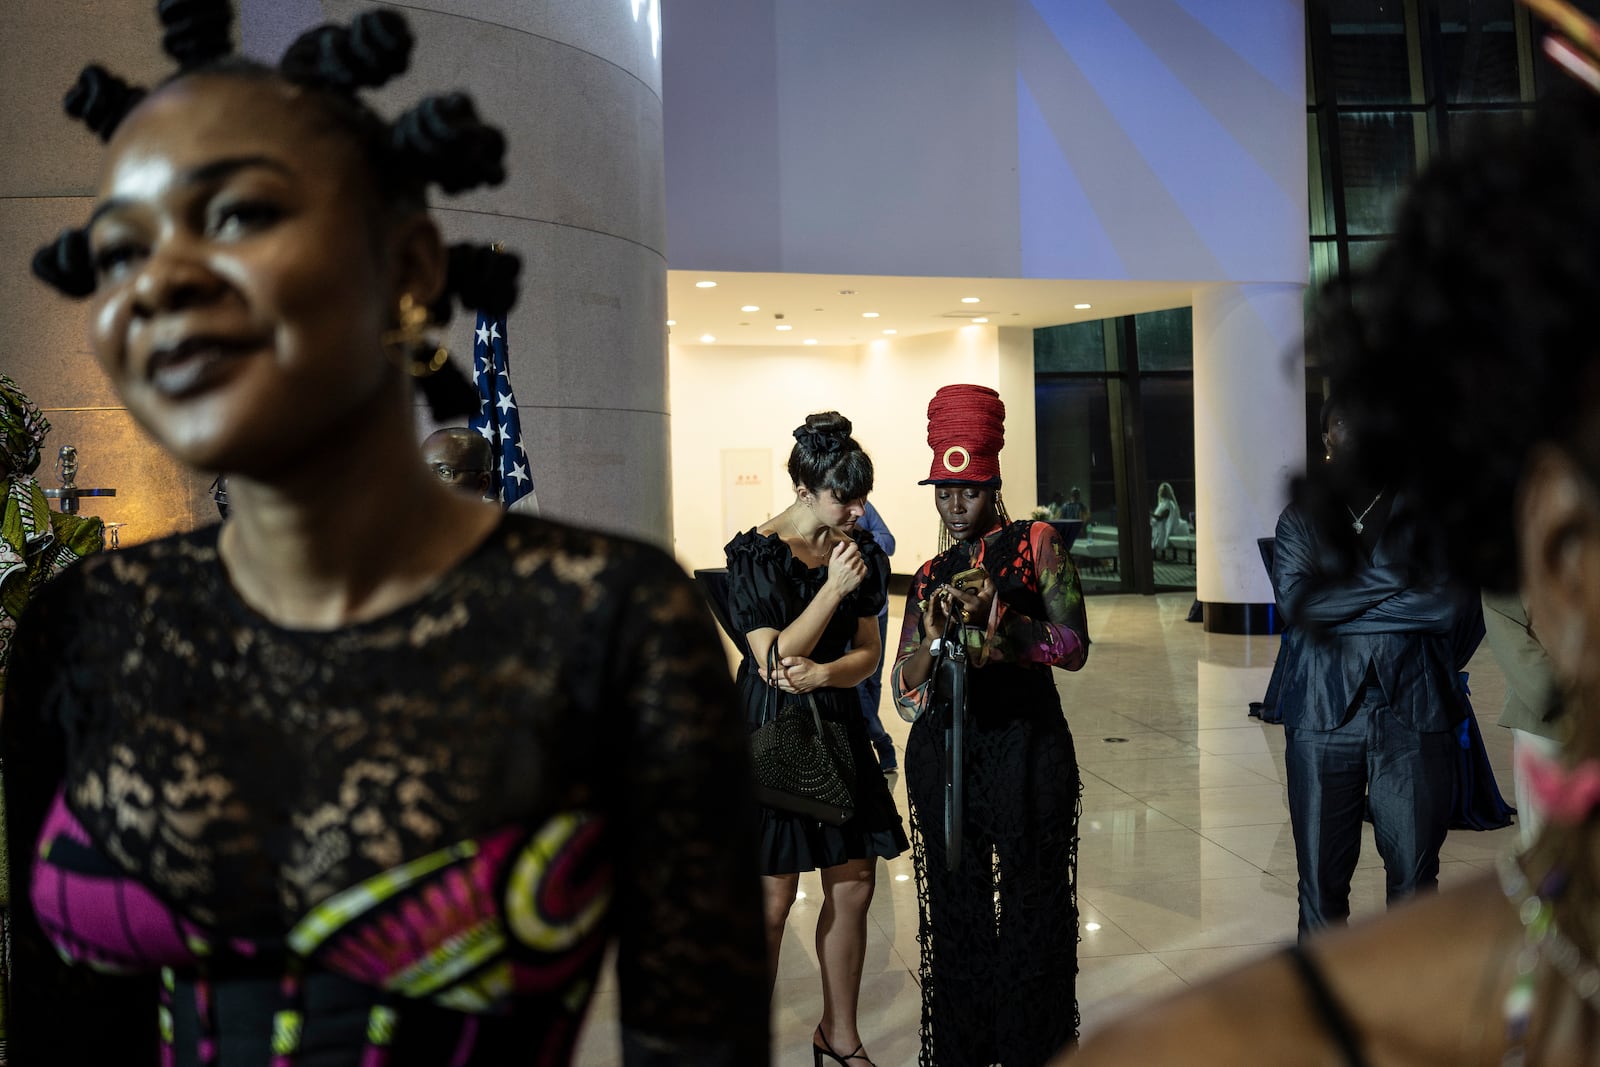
[1058,85,1600,1067]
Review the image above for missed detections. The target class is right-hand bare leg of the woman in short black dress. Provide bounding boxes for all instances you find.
[816,859,878,1064]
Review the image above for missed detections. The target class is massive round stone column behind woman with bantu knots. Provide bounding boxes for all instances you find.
[0,0,672,545]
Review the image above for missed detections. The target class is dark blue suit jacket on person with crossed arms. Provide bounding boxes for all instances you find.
[1272,501,1483,733]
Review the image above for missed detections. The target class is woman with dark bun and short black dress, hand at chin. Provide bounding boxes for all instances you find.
[726,411,907,1067]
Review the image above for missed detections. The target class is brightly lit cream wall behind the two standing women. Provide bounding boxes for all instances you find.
[669,326,1035,574]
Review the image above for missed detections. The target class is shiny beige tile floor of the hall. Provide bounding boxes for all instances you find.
[578,593,1515,1067]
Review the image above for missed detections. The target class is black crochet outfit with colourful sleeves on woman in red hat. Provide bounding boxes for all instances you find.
[894,522,1090,1067]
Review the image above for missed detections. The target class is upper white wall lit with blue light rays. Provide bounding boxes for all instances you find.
[662,0,1307,282]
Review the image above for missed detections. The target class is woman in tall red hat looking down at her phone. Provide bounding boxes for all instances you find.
[893,386,1090,1067]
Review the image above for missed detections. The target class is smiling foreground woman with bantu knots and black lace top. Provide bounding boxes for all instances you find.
[0,0,768,1067]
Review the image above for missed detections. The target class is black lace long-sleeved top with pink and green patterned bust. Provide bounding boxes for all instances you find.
[0,517,766,1067]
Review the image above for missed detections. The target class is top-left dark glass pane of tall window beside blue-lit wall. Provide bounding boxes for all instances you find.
[1307,0,1422,104]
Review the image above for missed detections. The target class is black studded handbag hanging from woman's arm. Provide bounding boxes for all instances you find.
[750,641,856,825]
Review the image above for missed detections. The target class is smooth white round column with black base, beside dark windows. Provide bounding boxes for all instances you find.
[1194,283,1306,633]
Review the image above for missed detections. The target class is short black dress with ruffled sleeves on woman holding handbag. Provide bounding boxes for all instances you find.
[725,530,910,875]
